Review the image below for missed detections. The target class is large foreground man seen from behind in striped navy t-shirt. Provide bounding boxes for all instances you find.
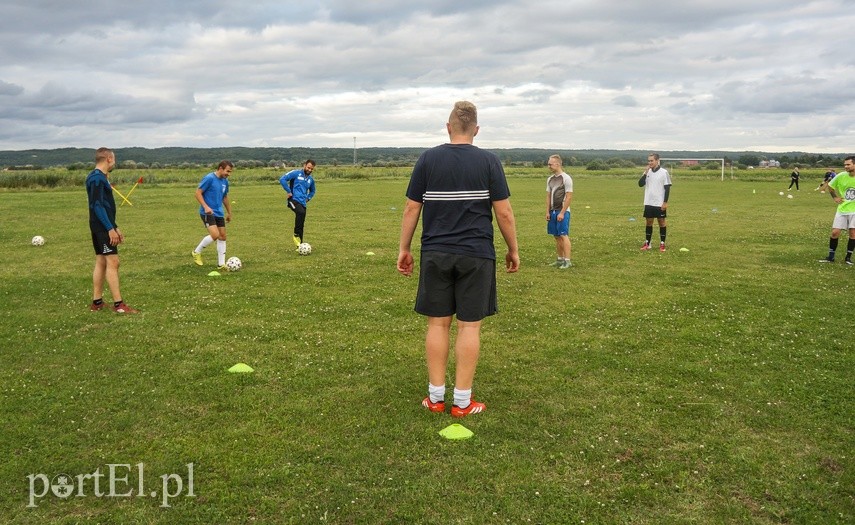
[397,101,520,417]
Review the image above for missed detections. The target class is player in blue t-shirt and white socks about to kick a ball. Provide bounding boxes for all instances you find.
[191,160,235,270]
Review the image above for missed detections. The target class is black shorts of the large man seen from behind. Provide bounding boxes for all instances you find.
[415,251,499,322]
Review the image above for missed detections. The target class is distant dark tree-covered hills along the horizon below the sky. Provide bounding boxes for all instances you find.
[0,147,845,168]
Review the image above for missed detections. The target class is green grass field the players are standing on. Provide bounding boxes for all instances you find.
[0,171,855,524]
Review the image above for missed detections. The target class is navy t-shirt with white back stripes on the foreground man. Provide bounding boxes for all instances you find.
[407,144,511,260]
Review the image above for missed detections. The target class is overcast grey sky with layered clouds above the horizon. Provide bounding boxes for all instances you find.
[0,0,855,153]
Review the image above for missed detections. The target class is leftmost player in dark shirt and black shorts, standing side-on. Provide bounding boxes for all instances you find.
[86,148,139,314]
